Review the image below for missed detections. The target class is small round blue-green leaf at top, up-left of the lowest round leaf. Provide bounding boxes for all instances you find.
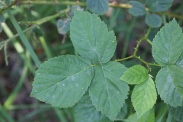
[128,1,146,17]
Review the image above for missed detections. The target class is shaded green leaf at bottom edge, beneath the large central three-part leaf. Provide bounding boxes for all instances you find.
[74,95,110,122]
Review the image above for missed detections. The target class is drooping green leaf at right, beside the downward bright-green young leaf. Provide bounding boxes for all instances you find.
[155,67,183,107]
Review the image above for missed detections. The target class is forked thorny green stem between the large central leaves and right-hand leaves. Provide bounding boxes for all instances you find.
[115,28,160,71]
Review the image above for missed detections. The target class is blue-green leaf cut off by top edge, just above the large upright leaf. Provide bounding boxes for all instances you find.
[86,0,109,15]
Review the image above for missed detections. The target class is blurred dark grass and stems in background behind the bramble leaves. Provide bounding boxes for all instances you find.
[0,0,183,122]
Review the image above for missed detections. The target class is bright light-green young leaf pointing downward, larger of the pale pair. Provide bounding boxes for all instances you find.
[132,76,157,118]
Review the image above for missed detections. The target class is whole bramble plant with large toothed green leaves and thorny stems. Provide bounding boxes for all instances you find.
[0,0,183,122]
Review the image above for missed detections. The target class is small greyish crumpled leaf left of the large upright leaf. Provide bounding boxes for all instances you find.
[57,18,70,35]
